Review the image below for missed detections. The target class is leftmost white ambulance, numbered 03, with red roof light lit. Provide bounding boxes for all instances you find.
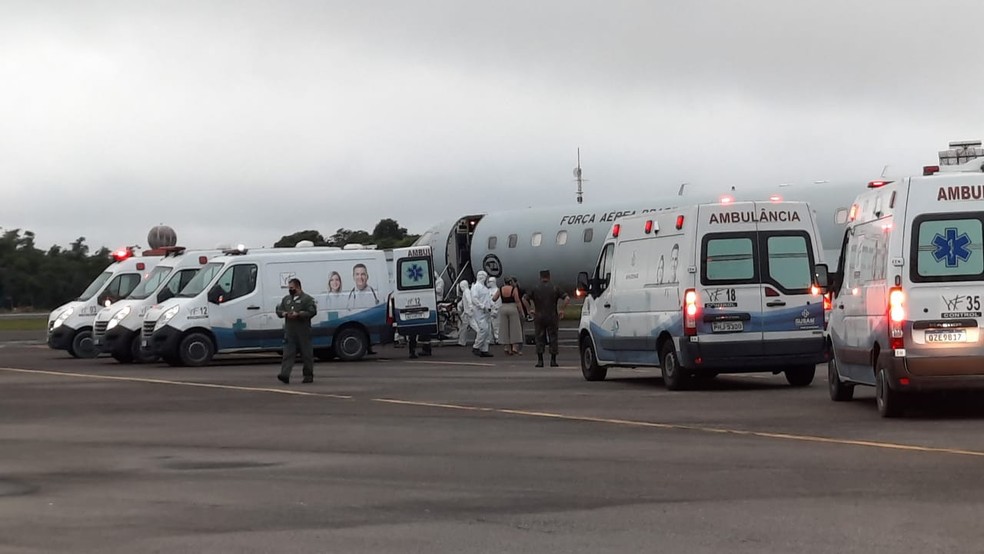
[48,248,162,358]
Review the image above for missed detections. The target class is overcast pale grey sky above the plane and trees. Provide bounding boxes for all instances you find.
[0,0,984,247]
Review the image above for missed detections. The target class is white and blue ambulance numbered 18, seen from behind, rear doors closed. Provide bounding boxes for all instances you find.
[578,199,827,390]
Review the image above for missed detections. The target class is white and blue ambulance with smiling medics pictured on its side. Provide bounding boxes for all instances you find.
[141,247,437,366]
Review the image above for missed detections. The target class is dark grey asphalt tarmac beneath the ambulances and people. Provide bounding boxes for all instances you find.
[0,337,984,554]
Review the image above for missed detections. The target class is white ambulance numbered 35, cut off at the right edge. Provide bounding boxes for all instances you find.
[828,142,984,417]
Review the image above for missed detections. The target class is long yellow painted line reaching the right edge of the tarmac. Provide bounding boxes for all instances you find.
[372,398,984,457]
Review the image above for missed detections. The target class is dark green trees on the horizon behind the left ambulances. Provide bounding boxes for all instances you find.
[0,219,417,310]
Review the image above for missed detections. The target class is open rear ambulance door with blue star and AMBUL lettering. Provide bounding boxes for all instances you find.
[390,246,437,335]
